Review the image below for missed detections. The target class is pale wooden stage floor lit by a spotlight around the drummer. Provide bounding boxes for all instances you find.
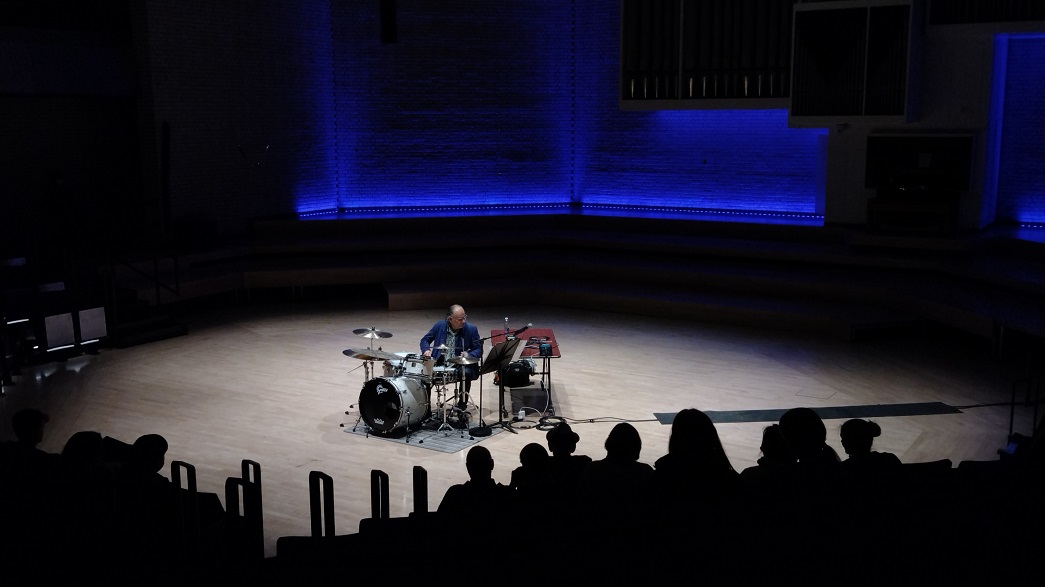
[0,299,1035,556]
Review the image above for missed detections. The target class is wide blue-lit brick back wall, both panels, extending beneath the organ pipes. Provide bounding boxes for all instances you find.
[333,0,825,213]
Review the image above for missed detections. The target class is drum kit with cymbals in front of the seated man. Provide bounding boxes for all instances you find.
[342,328,478,435]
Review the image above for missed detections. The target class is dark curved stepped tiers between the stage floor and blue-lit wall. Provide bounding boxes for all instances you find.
[96,215,1045,344]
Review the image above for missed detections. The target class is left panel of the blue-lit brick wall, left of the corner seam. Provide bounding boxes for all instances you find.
[332,0,575,209]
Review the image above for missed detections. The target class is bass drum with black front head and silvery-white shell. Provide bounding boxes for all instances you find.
[359,377,428,433]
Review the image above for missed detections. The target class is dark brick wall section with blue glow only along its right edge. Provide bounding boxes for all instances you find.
[146,0,336,237]
